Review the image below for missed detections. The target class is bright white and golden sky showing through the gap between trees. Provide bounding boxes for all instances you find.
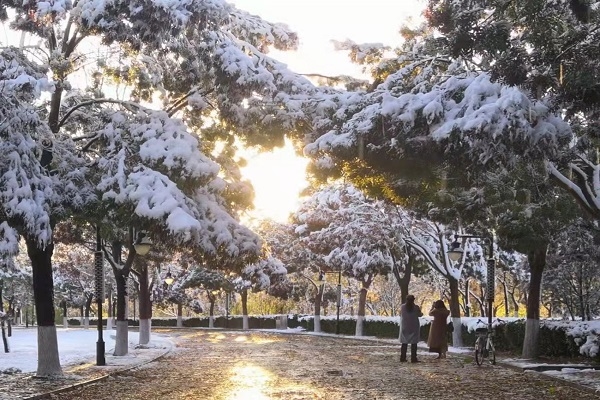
[236,0,425,222]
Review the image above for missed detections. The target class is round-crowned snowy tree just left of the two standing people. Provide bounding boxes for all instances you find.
[294,184,398,336]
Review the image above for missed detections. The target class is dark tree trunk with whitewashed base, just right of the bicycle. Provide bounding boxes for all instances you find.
[521,245,548,359]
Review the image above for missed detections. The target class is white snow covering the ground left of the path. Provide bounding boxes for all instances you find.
[0,327,170,372]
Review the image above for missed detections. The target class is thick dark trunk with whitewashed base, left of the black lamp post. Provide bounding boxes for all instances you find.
[26,238,63,378]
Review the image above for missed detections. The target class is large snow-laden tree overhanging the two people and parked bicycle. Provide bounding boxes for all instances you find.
[306,0,598,358]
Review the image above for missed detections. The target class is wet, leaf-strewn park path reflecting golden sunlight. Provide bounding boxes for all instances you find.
[41,330,599,400]
